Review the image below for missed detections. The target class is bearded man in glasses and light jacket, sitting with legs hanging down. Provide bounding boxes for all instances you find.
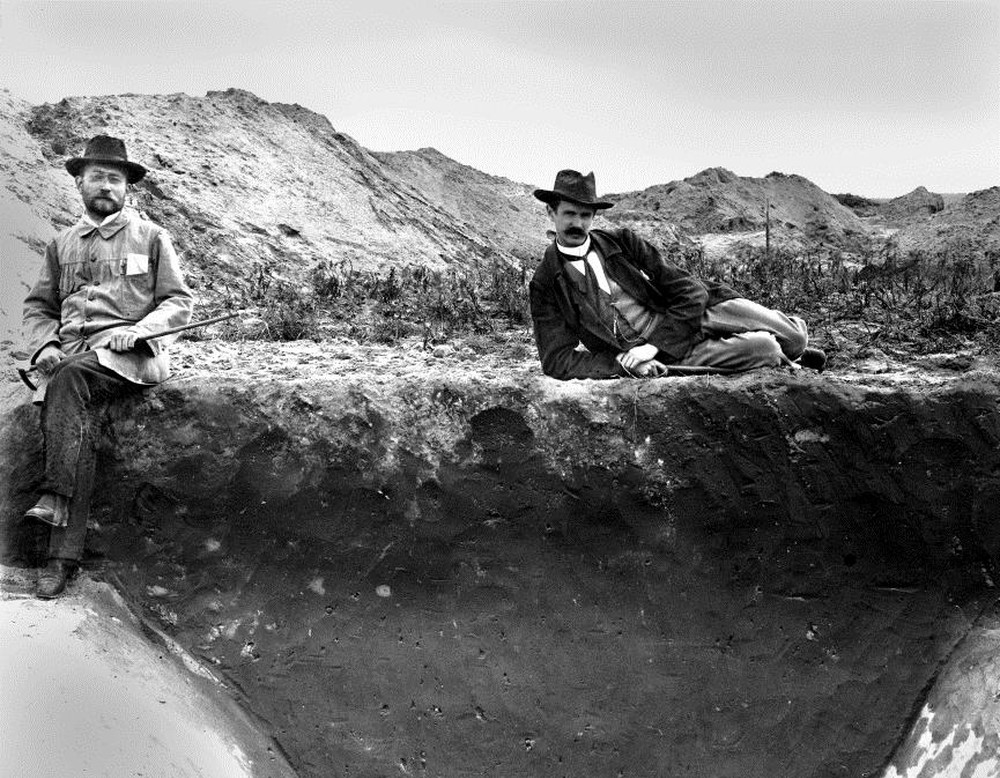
[24,135,193,598]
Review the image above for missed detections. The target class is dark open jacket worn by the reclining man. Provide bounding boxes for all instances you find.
[530,229,739,379]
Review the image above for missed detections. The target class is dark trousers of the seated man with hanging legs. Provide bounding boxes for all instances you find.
[41,353,139,560]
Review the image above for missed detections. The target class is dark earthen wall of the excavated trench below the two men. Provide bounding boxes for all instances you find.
[0,373,1000,778]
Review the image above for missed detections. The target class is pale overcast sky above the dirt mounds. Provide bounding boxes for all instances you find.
[0,0,1000,197]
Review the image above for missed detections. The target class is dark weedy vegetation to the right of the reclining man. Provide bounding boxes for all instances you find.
[675,233,1000,357]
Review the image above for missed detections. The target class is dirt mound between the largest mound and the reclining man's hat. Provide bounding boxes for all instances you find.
[372,148,550,262]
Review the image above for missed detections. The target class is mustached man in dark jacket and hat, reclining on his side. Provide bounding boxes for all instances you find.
[530,170,826,379]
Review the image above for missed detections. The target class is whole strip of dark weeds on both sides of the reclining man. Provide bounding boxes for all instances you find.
[217,232,1000,366]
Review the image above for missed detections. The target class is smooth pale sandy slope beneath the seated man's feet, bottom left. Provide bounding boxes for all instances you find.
[0,568,293,778]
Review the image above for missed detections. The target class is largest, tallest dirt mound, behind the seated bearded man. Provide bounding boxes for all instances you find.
[3,89,509,318]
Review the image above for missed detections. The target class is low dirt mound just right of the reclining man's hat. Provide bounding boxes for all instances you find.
[608,168,866,248]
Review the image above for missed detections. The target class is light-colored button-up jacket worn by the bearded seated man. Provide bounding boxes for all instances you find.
[24,210,194,394]
